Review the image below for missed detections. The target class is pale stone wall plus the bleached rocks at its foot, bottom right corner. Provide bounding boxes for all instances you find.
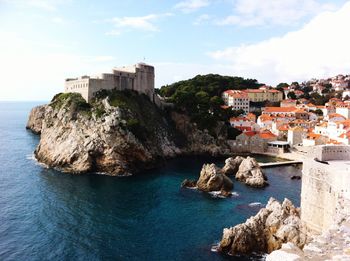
[266,145,350,261]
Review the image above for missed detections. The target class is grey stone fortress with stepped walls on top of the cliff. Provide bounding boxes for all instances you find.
[64,63,160,105]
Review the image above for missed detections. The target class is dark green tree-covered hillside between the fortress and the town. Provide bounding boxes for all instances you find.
[159,74,261,134]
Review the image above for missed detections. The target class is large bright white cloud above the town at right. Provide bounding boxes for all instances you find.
[209,2,350,84]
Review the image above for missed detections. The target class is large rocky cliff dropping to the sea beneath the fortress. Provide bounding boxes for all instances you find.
[27,92,234,175]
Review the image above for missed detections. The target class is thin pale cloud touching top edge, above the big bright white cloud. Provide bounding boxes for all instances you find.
[216,0,335,26]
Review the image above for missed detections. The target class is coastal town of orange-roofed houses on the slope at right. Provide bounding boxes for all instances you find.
[222,75,350,154]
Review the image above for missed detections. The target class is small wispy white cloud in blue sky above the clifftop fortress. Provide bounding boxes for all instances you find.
[107,13,172,35]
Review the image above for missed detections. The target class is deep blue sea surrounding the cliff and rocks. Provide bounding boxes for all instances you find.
[0,102,301,261]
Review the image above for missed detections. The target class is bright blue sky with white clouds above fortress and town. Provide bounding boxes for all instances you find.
[0,0,350,101]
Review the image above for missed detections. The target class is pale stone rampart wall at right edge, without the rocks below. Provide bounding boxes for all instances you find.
[301,146,350,233]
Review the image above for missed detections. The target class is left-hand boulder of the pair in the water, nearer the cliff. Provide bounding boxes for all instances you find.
[197,164,233,192]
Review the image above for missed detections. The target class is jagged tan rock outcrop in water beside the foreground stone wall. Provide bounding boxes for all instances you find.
[218,198,306,255]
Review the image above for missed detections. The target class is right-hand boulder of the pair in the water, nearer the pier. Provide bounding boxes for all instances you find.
[236,157,268,187]
